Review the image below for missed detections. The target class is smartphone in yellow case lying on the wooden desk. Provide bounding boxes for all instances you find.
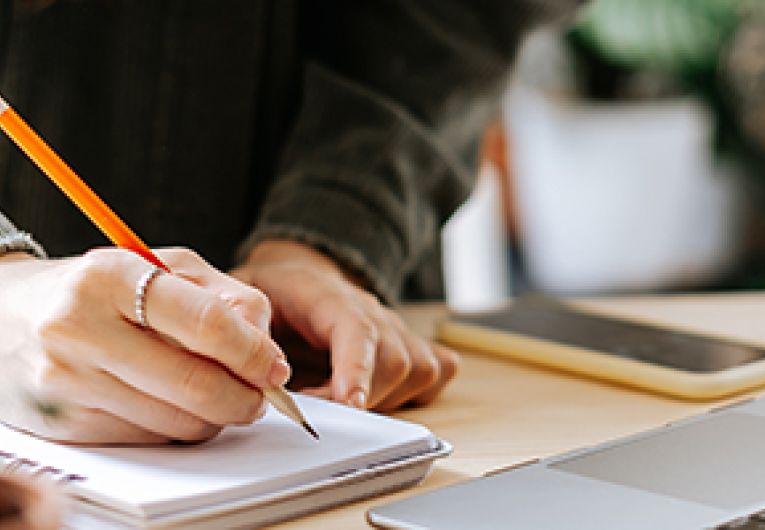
[437,297,765,400]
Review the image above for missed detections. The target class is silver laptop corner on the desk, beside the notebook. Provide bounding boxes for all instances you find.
[367,398,765,530]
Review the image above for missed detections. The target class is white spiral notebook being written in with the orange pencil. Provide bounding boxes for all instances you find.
[0,395,449,529]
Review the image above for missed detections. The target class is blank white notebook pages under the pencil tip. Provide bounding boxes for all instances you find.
[0,396,436,516]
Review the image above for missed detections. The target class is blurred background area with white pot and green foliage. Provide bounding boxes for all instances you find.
[443,0,765,310]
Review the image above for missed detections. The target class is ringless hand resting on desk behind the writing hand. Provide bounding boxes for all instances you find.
[232,241,458,411]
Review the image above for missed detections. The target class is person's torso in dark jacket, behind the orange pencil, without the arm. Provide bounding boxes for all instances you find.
[0,0,300,267]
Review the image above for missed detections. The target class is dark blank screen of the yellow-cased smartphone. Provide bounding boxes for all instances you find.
[455,298,765,373]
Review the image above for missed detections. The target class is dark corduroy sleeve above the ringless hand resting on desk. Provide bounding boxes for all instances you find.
[243,0,575,302]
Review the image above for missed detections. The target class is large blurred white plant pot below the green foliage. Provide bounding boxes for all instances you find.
[505,85,743,294]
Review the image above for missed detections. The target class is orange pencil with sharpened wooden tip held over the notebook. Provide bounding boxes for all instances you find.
[0,96,319,438]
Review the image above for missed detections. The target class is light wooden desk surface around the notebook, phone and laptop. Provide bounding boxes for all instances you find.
[278,294,765,530]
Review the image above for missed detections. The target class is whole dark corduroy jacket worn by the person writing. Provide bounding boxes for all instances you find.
[0,0,569,301]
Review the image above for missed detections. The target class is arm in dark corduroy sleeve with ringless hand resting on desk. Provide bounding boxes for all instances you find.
[237,0,576,409]
